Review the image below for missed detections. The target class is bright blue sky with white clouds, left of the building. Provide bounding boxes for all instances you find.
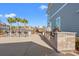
[0,3,47,26]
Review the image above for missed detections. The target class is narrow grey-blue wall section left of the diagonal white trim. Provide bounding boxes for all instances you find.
[47,3,63,29]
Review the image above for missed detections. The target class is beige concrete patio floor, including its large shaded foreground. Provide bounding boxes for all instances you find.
[0,34,75,56]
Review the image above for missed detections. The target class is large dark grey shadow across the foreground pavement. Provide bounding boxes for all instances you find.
[0,42,55,56]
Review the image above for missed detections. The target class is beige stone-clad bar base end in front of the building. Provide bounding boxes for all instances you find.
[52,32,76,51]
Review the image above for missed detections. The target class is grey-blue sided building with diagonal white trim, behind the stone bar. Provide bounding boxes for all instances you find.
[47,3,79,35]
